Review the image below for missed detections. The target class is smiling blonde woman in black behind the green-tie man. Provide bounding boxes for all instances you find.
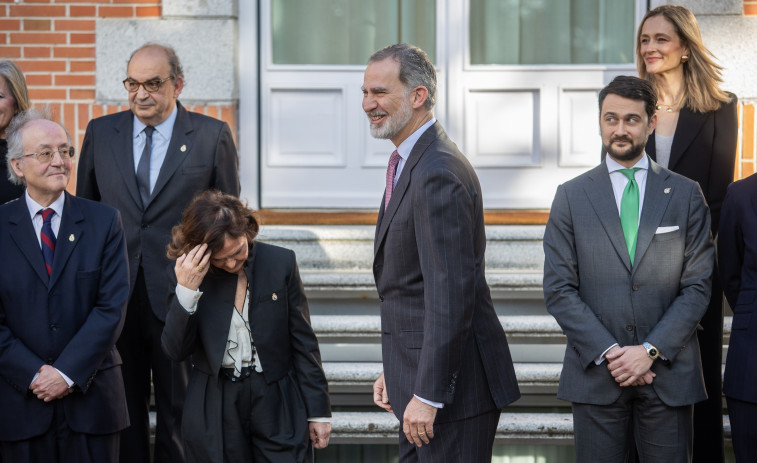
[636,5,738,463]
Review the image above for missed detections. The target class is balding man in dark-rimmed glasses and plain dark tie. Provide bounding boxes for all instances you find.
[76,43,239,463]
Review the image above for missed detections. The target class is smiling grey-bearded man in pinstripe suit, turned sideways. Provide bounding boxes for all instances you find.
[363,44,520,463]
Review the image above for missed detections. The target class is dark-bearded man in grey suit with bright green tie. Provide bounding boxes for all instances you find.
[544,76,714,463]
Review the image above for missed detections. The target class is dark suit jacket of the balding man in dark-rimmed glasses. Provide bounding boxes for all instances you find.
[76,102,239,320]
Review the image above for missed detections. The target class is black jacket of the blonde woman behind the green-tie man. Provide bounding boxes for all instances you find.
[646,94,739,236]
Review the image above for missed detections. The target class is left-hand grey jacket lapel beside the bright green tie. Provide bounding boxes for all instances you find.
[584,163,638,272]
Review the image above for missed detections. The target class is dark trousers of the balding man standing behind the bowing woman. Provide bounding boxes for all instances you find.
[116,268,191,463]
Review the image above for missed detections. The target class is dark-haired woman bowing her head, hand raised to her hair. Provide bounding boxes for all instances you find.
[162,191,331,463]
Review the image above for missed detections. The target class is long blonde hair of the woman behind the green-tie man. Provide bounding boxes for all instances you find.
[636,5,731,113]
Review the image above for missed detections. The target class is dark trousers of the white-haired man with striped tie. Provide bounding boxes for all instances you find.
[0,398,119,463]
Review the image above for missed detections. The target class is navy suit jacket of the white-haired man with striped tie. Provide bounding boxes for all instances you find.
[0,194,129,441]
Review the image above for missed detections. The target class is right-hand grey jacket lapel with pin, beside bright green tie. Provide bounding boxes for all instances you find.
[634,161,675,271]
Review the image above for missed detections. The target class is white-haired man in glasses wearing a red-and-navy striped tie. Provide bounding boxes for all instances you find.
[0,110,129,463]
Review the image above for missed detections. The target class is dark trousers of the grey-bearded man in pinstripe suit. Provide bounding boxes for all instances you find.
[399,410,501,463]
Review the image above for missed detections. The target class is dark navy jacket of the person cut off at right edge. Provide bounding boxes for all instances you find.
[718,175,757,402]
